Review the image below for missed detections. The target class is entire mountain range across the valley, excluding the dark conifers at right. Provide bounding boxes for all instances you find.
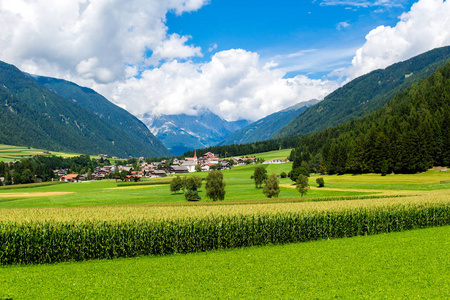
[0,47,450,157]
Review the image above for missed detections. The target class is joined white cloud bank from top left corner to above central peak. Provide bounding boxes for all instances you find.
[0,0,337,120]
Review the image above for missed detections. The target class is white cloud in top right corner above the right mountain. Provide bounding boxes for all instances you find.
[347,0,450,79]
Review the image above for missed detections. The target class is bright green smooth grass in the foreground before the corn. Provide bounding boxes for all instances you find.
[0,226,450,299]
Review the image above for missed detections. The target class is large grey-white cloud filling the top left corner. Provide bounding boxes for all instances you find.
[0,0,207,83]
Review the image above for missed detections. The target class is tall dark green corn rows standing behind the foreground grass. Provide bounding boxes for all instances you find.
[0,198,450,265]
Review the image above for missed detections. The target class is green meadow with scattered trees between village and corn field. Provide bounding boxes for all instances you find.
[0,164,450,208]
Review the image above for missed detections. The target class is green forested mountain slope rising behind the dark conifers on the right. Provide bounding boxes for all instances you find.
[274,46,450,138]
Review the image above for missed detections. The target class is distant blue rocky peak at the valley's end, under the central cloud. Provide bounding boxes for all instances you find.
[141,109,248,155]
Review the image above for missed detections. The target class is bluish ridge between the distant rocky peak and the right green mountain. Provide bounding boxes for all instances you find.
[220,100,319,145]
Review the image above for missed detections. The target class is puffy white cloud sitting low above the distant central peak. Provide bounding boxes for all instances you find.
[110,49,338,120]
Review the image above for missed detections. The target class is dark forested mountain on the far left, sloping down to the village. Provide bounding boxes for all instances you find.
[0,62,170,157]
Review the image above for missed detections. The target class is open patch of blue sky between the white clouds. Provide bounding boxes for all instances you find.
[166,0,415,78]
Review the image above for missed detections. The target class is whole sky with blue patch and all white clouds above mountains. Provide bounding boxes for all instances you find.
[0,0,450,121]
